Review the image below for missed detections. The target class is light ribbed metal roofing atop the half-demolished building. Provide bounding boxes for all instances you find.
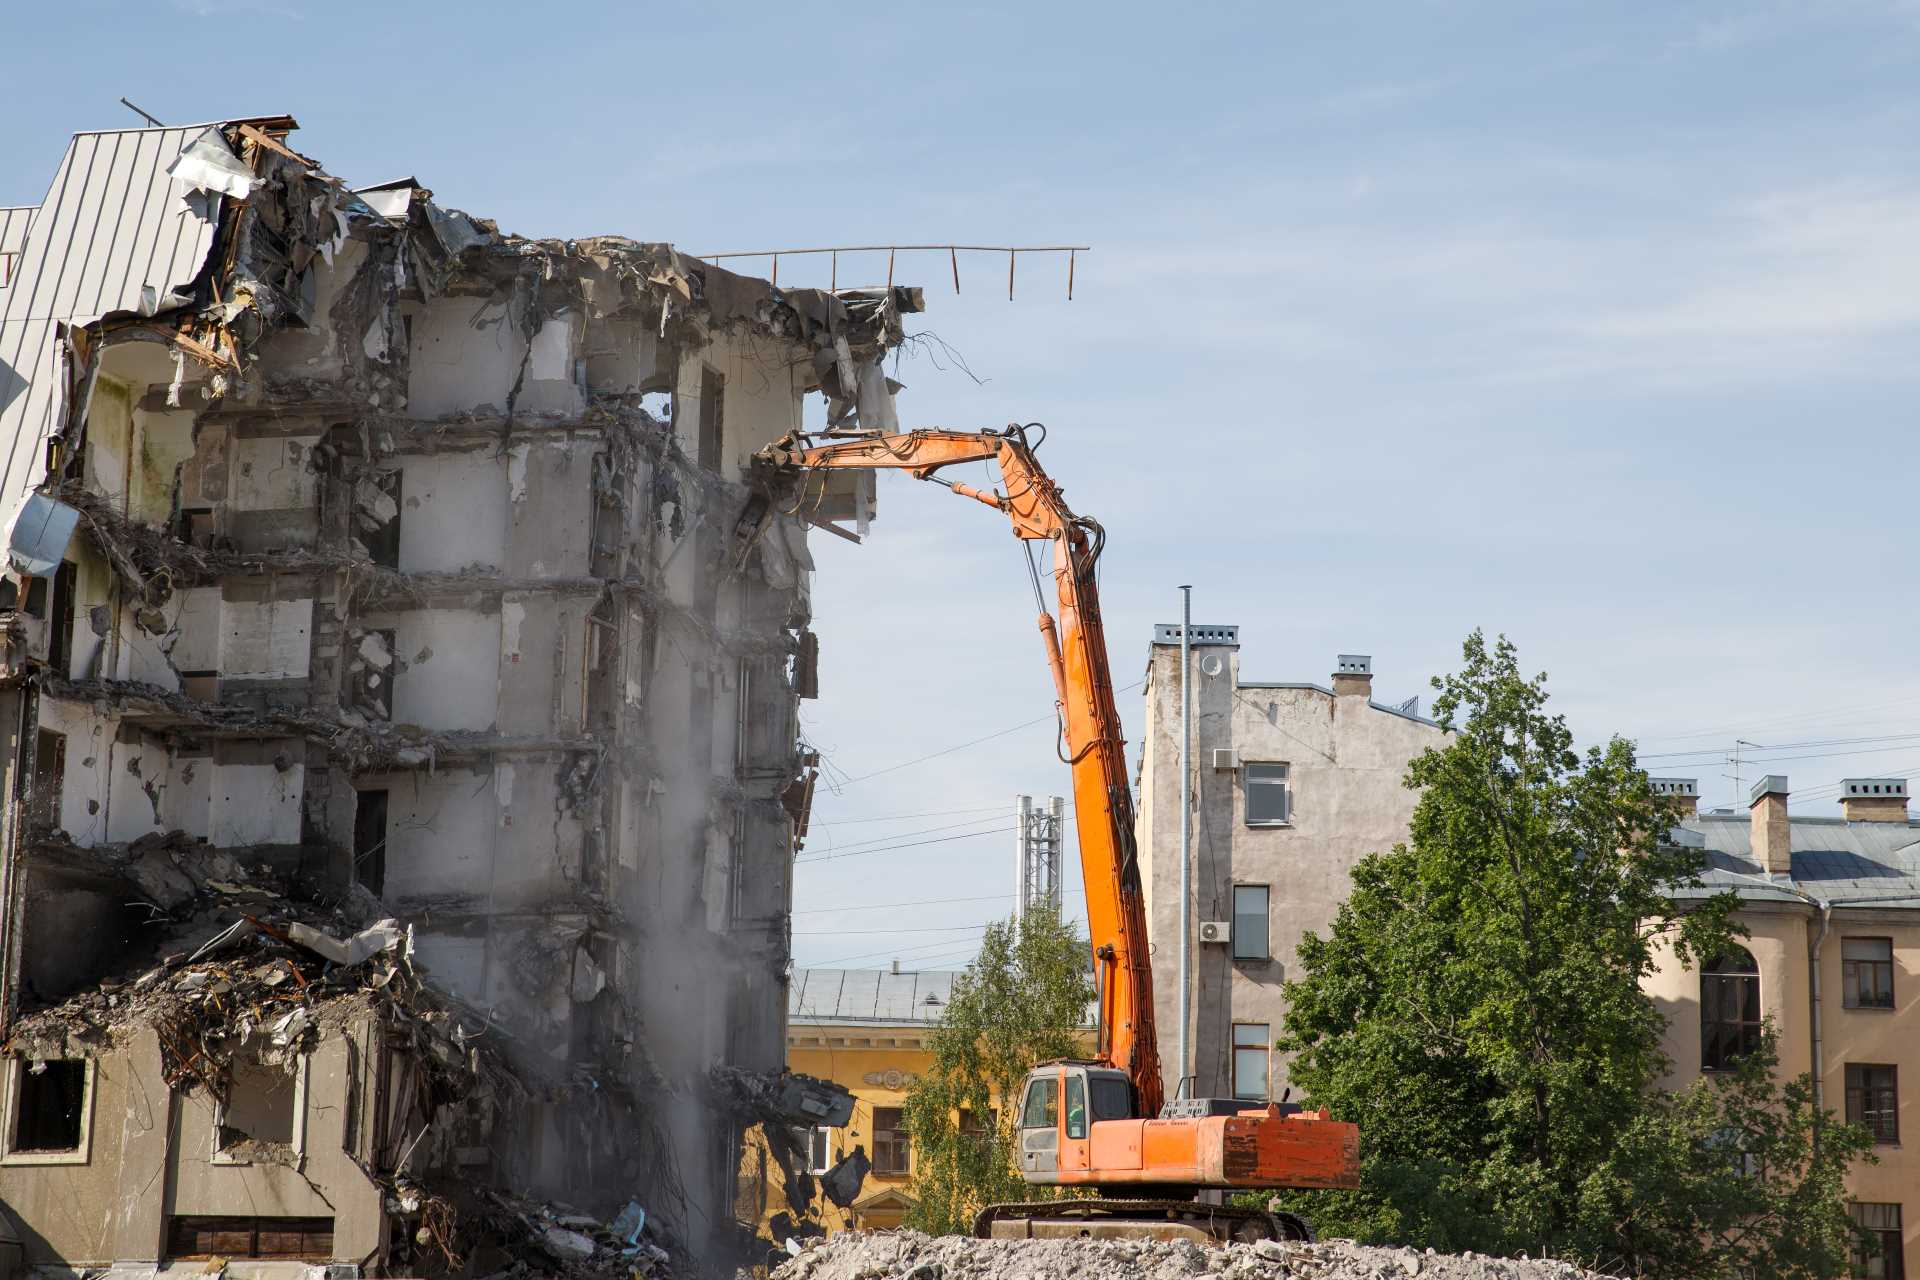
[0,125,230,512]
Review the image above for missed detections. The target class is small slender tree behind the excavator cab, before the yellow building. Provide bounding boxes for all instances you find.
[904,912,1094,1234]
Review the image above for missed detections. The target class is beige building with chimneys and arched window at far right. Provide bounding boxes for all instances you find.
[1645,775,1920,1278]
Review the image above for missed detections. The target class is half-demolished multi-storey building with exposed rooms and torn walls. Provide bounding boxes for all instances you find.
[0,117,920,1272]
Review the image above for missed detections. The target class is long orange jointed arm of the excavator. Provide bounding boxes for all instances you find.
[758,424,1162,1117]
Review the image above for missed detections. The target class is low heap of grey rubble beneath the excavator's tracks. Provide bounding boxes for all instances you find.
[774,1232,1603,1280]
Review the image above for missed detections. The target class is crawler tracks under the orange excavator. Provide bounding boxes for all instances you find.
[973,1197,1313,1245]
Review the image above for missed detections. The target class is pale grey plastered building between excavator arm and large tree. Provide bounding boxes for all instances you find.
[1139,624,1446,1100]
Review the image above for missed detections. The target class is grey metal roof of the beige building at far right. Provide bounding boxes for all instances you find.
[1674,814,1920,906]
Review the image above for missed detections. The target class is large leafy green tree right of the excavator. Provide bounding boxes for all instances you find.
[1281,631,1853,1276]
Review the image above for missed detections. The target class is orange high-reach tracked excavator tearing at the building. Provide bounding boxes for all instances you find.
[756,424,1359,1244]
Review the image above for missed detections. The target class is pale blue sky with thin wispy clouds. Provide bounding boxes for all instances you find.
[0,0,1920,967]
